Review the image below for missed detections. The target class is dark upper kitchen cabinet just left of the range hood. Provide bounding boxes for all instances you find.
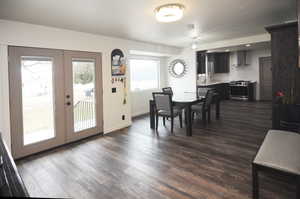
[208,52,230,73]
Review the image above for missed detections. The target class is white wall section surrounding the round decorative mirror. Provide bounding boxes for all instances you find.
[166,48,197,93]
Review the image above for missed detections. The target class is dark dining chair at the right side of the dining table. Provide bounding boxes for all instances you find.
[192,89,215,124]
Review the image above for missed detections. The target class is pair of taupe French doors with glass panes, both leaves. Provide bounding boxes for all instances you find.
[9,47,102,158]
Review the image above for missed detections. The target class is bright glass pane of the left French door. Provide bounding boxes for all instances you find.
[21,57,55,145]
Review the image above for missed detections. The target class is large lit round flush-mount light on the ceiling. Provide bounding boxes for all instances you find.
[155,4,184,23]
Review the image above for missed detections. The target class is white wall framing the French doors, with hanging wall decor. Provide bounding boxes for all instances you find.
[0,20,180,151]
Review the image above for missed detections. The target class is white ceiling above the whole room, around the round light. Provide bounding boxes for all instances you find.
[0,0,296,47]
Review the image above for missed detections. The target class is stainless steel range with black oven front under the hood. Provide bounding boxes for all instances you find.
[229,80,254,101]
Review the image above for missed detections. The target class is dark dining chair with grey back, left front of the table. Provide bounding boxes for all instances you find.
[152,92,182,134]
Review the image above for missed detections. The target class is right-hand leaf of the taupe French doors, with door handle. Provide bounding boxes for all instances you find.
[64,51,103,141]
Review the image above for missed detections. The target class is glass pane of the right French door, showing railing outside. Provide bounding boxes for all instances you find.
[72,59,96,132]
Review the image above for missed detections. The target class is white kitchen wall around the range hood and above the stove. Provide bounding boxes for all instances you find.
[212,49,271,100]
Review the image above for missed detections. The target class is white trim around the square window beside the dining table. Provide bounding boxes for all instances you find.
[128,55,161,93]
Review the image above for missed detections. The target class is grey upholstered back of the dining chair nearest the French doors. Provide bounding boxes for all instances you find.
[152,92,173,113]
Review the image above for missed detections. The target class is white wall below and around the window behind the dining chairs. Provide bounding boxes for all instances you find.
[129,56,167,117]
